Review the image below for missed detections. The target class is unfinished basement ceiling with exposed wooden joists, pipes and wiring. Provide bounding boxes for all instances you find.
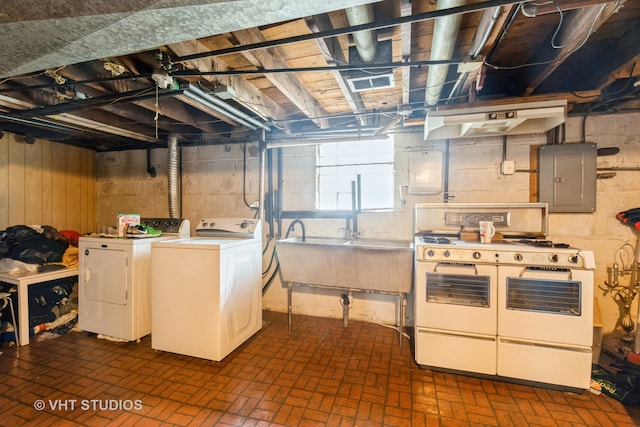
[0,0,640,150]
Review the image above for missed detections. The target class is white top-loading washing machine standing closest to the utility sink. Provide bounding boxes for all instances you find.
[151,218,262,361]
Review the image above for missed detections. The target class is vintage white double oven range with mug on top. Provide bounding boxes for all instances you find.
[414,203,595,389]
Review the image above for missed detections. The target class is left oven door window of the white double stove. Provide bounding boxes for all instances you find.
[427,273,490,307]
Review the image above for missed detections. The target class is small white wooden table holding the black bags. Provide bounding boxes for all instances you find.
[0,267,78,346]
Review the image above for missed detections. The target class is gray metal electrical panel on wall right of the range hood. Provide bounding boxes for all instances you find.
[538,144,598,212]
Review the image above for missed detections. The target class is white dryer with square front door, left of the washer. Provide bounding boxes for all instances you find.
[78,218,191,341]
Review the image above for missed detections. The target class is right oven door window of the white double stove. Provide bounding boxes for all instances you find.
[507,277,582,316]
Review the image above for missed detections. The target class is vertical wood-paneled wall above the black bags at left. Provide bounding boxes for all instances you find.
[0,132,96,233]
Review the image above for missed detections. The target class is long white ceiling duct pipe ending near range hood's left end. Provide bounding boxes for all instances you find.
[425,0,465,106]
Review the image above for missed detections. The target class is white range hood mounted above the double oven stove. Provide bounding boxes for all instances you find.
[424,100,567,141]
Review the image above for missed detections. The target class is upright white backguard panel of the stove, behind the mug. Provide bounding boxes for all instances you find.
[414,203,549,237]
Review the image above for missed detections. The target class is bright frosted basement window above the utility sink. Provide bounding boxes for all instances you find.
[316,138,394,210]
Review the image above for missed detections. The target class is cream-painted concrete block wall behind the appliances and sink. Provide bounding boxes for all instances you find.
[96,113,640,332]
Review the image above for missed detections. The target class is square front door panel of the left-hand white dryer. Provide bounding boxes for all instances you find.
[82,248,127,305]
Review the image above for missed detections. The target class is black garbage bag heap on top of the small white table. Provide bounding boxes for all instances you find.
[0,225,69,264]
